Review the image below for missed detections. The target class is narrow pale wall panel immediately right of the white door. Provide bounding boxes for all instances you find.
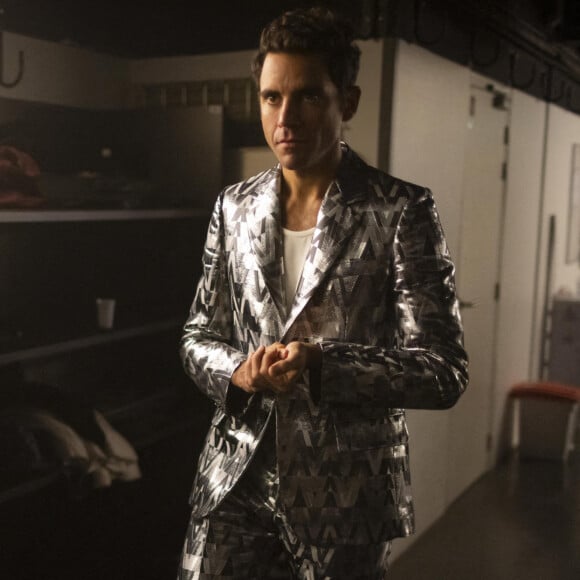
[492,91,547,459]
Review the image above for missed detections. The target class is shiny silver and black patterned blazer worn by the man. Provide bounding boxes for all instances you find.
[181,146,467,542]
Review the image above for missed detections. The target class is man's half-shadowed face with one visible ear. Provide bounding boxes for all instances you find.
[260,52,358,175]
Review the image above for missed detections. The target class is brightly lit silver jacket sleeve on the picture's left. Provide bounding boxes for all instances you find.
[180,193,246,411]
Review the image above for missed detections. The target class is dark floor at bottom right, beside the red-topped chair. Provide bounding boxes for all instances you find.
[389,452,580,580]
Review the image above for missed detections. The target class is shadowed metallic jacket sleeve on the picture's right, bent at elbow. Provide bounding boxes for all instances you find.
[321,190,468,409]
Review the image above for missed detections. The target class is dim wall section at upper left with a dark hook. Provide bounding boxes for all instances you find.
[0,32,129,109]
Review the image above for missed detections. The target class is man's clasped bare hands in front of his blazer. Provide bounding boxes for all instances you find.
[231,341,322,393]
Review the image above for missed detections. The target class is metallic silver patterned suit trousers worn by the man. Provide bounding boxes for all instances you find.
[178,421,391,580]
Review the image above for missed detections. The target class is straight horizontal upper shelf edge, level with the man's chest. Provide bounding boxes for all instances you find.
[0,208,210,223]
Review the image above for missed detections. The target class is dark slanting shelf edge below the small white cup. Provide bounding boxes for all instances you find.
[0,318,184,366]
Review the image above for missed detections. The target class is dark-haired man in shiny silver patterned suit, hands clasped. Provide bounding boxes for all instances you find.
[180,9,467,580]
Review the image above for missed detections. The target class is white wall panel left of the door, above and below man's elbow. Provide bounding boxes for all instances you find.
[390,41,470,557]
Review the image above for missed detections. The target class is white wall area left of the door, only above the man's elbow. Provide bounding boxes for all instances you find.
[390,41,470,256]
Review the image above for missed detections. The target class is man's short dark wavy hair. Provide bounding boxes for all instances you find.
[252,6,360,94]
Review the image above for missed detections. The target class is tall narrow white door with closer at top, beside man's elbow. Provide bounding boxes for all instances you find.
[447,74,509,503]
